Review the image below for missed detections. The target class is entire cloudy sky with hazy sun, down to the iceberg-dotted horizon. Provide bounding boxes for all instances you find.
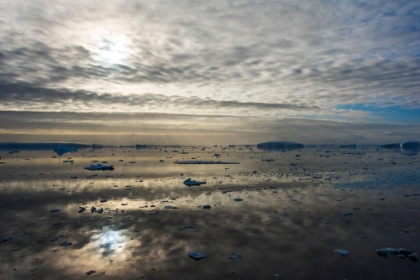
[0,0,420,145]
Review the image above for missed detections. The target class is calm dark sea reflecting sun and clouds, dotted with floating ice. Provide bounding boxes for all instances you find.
[0,147,420,279]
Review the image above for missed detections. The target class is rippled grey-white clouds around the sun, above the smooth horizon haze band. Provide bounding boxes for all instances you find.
[0,0,420,142]
